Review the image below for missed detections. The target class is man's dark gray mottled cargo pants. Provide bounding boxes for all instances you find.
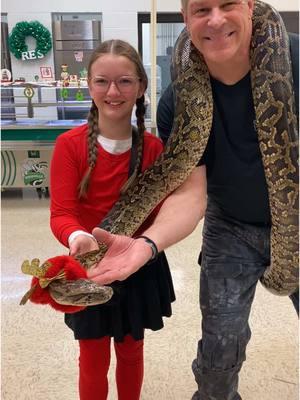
[192,201,298,400]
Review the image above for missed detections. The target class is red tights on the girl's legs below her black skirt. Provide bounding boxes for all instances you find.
[79,335,144,400]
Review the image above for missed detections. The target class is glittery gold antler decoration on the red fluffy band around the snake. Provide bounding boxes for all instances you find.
[20,258,66,305]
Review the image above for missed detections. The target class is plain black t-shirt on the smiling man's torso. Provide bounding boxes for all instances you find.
[199,73,270,224]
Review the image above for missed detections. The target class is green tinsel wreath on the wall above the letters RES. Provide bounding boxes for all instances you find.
[8,21,52,59]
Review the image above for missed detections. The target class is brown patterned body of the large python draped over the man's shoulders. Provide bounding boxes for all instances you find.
[20,1,299,306]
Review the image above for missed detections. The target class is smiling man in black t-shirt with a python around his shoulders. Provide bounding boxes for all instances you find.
[90,0,298,400]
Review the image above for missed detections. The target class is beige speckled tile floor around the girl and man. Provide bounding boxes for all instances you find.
[1,189,299,400]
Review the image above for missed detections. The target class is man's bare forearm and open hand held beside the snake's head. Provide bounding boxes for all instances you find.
[88,166,206,285]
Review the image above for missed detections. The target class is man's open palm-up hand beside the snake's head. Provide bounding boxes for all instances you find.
[87,228,152,285]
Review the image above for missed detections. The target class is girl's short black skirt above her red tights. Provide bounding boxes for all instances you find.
[65,252,175,342]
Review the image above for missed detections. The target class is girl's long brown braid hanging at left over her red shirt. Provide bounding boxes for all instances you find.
[78,100,99,198]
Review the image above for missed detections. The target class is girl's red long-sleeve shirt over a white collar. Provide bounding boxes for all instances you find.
[50,124,163,247]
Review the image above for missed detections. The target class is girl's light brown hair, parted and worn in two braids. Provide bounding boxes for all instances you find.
[78,40,148,198]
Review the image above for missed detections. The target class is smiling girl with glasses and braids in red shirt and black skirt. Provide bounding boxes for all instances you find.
[51,40,175,400]
